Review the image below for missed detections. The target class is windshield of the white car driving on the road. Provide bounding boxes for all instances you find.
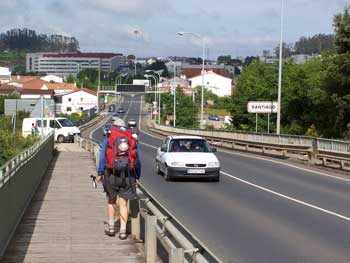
[169,139,209,152]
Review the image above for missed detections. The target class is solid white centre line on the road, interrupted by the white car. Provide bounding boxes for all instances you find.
[139,142,350,221]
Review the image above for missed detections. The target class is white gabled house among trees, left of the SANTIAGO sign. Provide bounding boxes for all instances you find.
[188,71,232,97]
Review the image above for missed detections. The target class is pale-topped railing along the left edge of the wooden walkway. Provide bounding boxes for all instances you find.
[0,132,54,258]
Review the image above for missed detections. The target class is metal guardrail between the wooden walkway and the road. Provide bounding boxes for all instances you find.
[74,136,221,263]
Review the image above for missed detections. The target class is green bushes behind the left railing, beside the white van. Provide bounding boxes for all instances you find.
[0,112,39,166]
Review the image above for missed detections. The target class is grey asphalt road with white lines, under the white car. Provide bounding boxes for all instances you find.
[92,95,350,263]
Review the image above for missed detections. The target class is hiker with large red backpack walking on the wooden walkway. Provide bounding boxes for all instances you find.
[96,118,140,240]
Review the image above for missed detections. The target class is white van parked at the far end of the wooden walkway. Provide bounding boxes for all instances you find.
[22,118,80,143]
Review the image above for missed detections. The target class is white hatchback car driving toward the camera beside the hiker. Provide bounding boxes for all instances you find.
[156,136,220,182]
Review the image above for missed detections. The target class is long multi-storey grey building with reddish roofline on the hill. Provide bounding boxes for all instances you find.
[26,53,125,77]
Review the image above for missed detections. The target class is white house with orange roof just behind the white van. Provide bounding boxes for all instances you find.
[56,88,97,114]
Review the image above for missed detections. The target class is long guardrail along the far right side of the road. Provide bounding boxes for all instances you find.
[148,122,350,171]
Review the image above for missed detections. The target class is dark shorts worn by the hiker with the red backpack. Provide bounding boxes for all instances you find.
[103,172,136,200]
